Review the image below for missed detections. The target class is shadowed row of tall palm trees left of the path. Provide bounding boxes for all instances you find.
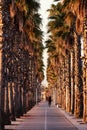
[0,0,44,130]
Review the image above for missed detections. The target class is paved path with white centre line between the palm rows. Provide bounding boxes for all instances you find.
[6,102,77,130]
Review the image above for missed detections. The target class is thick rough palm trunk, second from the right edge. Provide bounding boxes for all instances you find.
[74,34,83,117]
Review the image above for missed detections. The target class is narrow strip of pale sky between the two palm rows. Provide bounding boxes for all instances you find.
[39,0,53,87]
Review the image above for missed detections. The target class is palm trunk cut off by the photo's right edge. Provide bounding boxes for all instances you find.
[83,10,87,122]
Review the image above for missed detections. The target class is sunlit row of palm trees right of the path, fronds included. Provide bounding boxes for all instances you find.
[46,0,87,122]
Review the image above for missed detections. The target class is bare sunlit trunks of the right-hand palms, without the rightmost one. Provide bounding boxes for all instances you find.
[57,34,83,118]
